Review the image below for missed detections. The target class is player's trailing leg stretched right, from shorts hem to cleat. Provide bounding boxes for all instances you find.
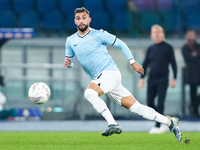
[109,85,182,141]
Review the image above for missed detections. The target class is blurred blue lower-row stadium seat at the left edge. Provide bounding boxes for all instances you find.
[0,11,16,28]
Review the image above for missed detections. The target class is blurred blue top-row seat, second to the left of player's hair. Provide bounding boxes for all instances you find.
[36,0,58,15]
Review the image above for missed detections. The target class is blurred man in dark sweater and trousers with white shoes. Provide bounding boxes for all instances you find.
[138,25,177,134]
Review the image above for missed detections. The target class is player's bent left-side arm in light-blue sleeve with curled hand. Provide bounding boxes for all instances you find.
[64,40,75,68]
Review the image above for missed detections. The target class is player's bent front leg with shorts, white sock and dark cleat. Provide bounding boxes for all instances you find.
[85,71,122,136]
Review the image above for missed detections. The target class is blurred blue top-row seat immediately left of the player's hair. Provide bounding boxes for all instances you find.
[59,0,80,14]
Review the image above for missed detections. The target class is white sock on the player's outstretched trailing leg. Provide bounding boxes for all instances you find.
[129,101,170,126]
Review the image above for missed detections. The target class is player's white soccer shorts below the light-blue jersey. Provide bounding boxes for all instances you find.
[91,70,132,105]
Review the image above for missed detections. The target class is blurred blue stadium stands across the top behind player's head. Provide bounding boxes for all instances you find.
[0,0,200,37]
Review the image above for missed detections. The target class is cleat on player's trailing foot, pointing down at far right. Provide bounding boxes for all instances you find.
[169,117,182,142]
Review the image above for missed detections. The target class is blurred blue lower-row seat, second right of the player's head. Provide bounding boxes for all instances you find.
[112,12,131,31]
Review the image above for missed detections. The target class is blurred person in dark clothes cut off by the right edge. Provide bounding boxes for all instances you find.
[181,30,200,117]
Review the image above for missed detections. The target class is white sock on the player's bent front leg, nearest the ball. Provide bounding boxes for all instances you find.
[85,89,117,125]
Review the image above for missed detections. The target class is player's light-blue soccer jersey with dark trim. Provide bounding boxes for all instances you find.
[65,28,133,79]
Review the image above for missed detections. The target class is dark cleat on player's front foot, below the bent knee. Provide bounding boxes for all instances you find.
[102,124,122,136]
